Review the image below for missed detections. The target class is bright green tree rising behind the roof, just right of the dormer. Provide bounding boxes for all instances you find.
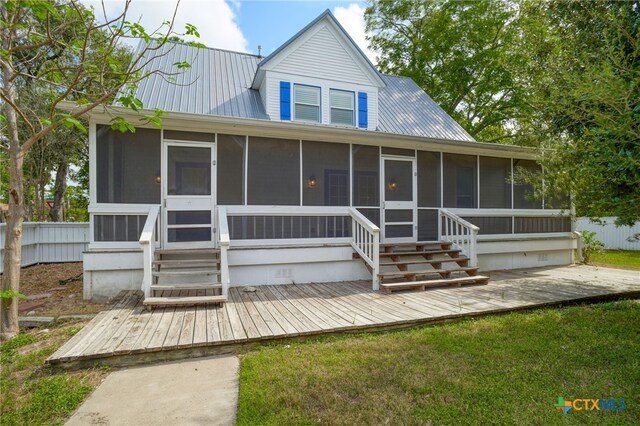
[365,0,528,142]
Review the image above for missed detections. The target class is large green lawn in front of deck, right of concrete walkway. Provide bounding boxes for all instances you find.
[238,301,640,425]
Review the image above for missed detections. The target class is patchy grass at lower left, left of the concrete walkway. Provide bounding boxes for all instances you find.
[0,323,107,425]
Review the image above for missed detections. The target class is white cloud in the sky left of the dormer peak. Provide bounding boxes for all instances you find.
[83,0,248,52]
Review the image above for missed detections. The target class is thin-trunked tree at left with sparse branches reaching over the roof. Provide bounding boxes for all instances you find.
[0,0,199,340]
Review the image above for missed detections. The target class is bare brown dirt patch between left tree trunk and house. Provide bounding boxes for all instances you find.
[18,262,105,317]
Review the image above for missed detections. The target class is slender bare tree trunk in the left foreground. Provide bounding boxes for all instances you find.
[0,79,24,341]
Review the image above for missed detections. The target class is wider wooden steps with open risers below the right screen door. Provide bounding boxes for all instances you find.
[362,241,489,293]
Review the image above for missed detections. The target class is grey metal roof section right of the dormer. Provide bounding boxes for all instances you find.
[377,75,475,141]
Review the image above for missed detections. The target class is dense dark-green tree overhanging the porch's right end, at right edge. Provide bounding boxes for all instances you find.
[524,1,640,225]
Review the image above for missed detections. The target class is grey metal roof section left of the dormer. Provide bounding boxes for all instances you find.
[137,43,269,120]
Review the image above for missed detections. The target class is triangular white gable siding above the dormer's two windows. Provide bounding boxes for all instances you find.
[273,25,373,84]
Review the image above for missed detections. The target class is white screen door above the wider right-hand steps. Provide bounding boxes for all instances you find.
[381,157,417,243]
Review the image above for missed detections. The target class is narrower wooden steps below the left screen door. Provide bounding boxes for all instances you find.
[144,249,226,307]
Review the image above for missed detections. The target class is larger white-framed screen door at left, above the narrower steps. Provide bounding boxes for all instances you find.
[162,140,215,248]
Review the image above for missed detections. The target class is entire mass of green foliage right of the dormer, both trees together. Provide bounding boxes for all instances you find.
[365,0,640,225]
